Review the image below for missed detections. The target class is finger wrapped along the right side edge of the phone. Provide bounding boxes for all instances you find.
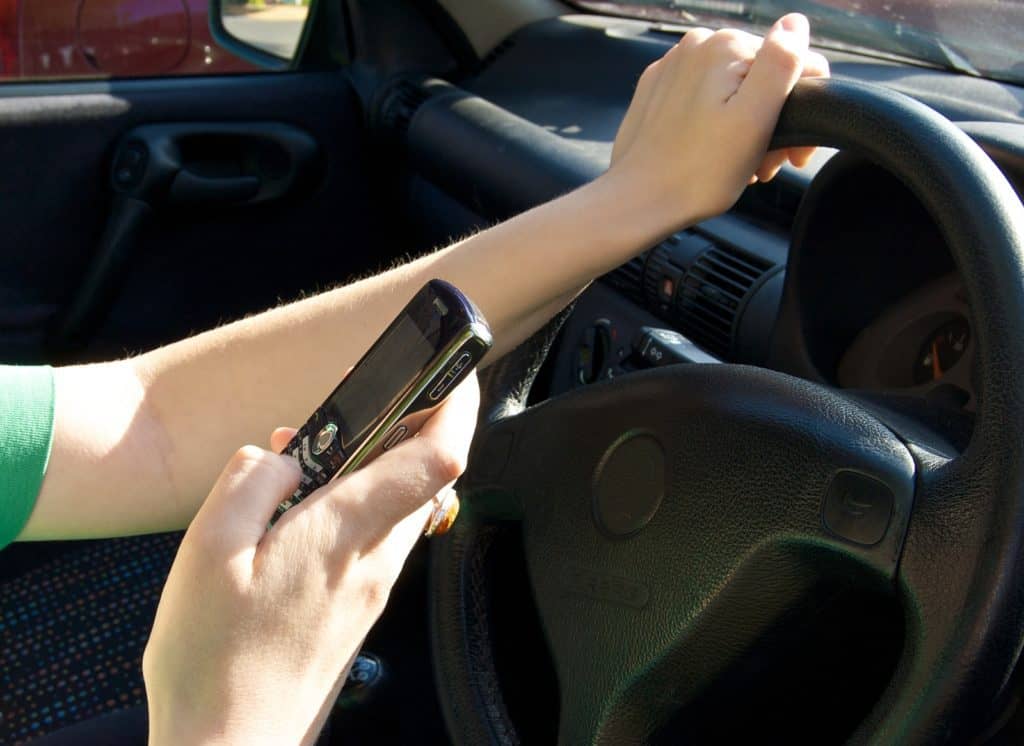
[315,376,479,550]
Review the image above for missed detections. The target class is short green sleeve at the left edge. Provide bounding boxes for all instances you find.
[0,365,53,548]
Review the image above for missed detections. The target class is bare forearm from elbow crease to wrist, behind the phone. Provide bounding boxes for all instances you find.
[137,171,671,517]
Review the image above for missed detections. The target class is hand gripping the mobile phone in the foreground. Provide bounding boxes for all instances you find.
[142,377,479,745]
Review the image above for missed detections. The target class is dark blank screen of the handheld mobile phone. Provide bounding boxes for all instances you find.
[328,314,435,448]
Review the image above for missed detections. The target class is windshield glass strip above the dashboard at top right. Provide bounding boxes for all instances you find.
[581,0,1024,83]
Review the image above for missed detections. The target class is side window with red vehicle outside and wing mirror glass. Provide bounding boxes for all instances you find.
[0,0,309,82]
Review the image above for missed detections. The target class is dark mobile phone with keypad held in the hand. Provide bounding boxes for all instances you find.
[269,279,492,526]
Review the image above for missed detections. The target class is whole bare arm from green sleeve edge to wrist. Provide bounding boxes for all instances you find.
[23,171,665,538]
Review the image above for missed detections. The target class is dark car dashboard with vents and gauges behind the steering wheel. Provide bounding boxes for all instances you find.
[378,16,1024,429]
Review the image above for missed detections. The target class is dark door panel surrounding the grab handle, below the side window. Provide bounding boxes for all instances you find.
[0,73,395,361]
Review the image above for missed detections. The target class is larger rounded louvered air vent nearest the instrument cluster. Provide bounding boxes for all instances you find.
[676,246,772,359]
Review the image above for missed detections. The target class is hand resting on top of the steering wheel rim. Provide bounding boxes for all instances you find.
[608,13,828,232]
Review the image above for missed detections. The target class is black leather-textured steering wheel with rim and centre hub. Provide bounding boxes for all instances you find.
[431,80,1024,744]
